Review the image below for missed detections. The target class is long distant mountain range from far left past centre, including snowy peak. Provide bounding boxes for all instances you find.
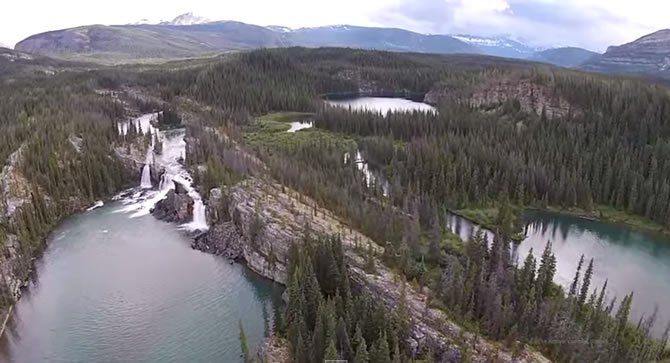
[16,21,482,63]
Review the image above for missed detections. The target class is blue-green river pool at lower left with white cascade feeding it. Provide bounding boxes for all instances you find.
[0,114,283,363]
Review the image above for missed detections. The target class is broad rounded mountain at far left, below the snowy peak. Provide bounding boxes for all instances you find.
[16,21,285,63]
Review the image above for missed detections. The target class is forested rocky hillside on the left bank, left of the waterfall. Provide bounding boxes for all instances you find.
[0,69,146,318]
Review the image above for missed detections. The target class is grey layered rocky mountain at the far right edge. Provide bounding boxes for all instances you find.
[581,29,670,80]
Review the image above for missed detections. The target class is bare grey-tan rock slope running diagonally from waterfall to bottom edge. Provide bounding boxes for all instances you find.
[193,178,546,362]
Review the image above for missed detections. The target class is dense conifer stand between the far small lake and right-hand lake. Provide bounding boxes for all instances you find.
[315,74,670,227]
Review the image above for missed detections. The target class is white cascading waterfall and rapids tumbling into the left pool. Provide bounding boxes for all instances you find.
[119,113,208,231]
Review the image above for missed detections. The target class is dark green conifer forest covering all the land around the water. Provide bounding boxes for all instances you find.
[0,48,670,363]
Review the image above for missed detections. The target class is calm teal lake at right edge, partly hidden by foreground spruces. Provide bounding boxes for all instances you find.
[447,211,670,335]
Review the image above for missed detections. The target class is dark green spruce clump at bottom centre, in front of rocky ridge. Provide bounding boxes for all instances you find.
[278,235,418,363]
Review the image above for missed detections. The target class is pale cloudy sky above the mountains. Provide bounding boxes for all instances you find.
[0,0,670,51]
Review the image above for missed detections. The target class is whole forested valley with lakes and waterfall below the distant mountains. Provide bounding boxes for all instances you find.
[0,42,670,363]
